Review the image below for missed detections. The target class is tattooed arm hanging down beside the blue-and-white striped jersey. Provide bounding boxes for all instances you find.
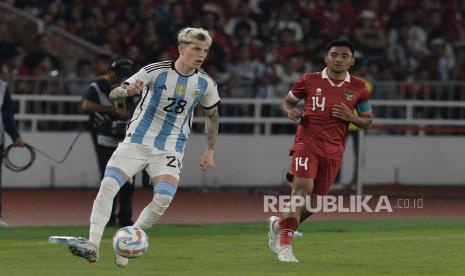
[200,106,220,172]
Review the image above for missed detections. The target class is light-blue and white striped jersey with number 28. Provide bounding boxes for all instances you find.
[123,61,220,153]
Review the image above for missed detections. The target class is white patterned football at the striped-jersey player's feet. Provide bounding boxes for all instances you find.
[113,226,149,258]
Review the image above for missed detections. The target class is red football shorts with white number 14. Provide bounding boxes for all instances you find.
[291,149,341,195]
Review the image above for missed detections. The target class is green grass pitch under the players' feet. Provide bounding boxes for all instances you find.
[0,220,465,276]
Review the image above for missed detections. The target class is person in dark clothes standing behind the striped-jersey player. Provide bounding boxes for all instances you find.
[82,57,136,226]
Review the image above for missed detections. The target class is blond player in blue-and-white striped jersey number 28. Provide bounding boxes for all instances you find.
[69,28,220,266]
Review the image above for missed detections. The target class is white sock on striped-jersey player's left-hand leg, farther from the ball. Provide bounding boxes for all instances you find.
[89,177,120,247]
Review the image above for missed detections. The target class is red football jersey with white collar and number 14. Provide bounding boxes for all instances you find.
[291,69,369,160]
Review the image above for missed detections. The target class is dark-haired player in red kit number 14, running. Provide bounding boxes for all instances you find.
[269,40,373,262]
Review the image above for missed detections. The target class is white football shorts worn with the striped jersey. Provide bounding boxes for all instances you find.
[107,143,184,180]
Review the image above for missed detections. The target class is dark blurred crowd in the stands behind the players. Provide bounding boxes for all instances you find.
[0,0,465,98]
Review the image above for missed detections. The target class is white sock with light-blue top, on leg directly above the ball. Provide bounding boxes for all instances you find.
[134,182,177,230]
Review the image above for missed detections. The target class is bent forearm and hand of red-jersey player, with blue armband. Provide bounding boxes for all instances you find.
[331,101,373,129]
